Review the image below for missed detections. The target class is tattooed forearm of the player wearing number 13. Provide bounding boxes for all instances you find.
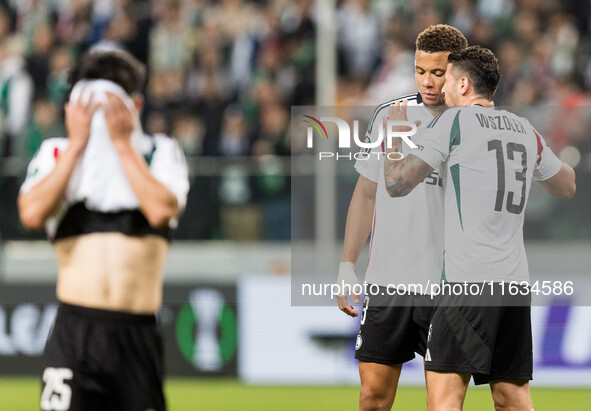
[384,150,433,197]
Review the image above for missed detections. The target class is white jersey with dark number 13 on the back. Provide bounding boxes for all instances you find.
[413,105,562,282]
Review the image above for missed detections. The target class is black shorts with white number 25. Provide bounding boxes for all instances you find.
[41,304,166,411]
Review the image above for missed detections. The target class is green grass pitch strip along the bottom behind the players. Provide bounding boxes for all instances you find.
[0,378,591,411]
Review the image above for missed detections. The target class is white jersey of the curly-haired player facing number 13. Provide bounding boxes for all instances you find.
[355,93,443,293]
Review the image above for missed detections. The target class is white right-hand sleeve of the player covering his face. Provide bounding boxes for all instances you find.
[150,134,189,210]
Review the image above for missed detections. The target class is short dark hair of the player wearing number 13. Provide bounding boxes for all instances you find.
[447,46,501,100]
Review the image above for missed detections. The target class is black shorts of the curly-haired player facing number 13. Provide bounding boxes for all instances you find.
[355,286,433,364]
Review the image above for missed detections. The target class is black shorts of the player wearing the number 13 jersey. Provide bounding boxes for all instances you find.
[425,286,533,385]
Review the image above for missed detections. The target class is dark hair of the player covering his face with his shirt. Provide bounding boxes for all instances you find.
[68,48,146,94]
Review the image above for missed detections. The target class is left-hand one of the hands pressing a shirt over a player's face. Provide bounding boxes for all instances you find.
[64,91,98,150]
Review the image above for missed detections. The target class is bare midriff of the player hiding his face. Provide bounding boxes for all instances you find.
[55,233,168,314]
